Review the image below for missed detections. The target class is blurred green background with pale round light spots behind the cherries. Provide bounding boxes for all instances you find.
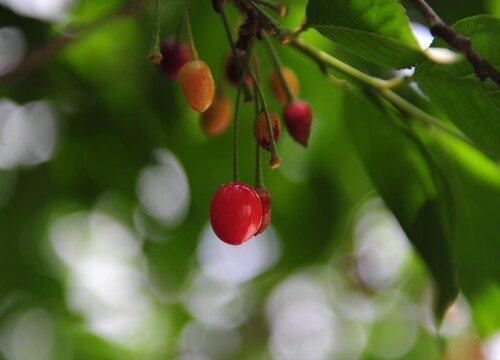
[0,0,500,360]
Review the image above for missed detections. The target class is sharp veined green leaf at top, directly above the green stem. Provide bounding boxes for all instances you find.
[306,0,424,69]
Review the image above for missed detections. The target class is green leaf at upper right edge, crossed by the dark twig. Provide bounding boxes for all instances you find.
[416,15,500,158]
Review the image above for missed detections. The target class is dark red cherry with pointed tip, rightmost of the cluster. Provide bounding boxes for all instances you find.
[283,100,312,147]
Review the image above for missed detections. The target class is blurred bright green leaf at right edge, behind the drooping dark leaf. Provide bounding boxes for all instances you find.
[429,133,500,333]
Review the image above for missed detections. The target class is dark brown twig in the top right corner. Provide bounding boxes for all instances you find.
[413,0,500,85]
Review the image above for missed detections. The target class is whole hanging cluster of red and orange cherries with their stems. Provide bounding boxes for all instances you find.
[155,1,312,245]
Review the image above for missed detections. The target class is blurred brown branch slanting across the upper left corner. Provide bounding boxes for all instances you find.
[0,0,148,83]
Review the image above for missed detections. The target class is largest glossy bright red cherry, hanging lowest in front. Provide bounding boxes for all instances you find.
[210,182,262,245]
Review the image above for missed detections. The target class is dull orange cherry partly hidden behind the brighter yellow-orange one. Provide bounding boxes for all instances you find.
[201,93,233,135]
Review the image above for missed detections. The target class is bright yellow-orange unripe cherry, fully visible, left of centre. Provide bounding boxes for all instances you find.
[179,60,215,112]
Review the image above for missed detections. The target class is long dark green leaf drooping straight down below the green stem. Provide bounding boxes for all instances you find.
[345,92,458,318]
